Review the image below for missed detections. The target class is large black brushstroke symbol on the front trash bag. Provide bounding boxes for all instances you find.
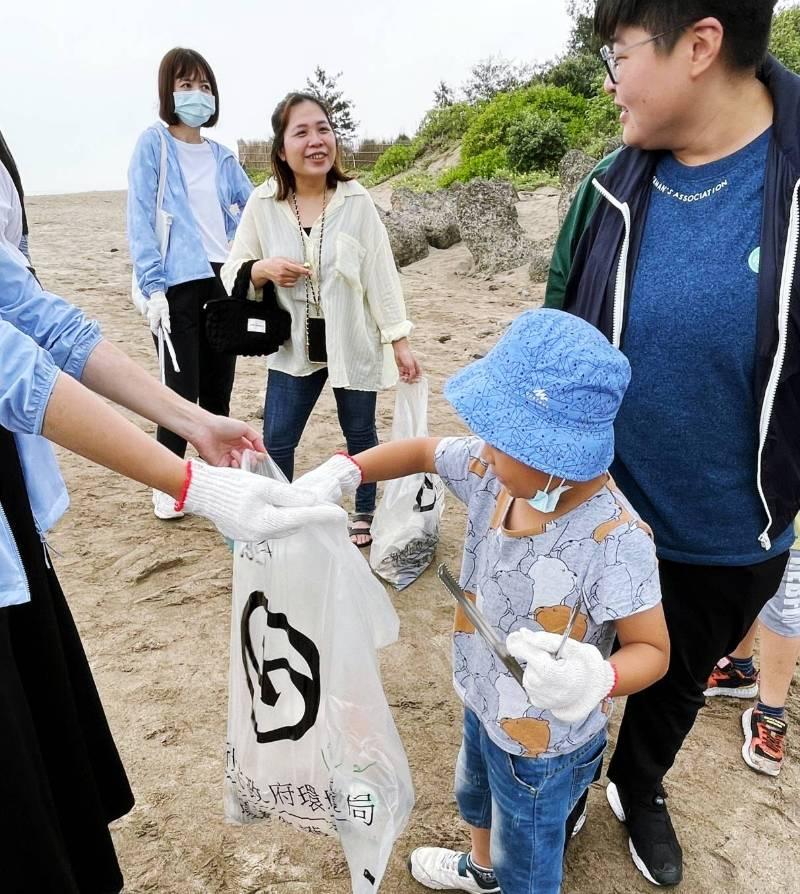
[241,590,322,744]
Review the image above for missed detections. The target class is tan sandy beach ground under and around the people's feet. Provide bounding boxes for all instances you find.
[27,189,800,894]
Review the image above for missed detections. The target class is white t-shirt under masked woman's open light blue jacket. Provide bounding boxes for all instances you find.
[175,140,228,264]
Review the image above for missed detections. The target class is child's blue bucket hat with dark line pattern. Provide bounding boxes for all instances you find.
[444,309,631,481]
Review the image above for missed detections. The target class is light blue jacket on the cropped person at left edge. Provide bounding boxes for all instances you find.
[0,246,102,608]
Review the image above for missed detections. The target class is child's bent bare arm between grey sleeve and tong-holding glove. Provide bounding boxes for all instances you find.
[609,605,669,696]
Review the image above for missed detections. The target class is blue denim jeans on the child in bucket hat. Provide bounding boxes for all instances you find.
[456,708,606,894]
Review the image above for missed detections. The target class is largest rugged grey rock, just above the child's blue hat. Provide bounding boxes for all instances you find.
[456,178,532,273]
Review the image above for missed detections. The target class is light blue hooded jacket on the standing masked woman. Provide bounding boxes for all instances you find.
[128,123,253,298]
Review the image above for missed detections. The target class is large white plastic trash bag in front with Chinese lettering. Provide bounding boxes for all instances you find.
[225,460,414,894]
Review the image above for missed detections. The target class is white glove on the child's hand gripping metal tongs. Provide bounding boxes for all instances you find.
[506,628,617,723]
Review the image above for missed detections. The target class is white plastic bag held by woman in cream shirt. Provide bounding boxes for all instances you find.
[369,379,444,590]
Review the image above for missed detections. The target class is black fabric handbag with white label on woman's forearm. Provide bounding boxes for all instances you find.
[203,261,292,357]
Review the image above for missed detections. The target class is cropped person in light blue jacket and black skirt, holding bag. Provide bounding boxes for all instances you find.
[0,246,342,894]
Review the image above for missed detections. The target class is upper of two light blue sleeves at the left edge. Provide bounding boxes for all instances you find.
[0,247,103,379]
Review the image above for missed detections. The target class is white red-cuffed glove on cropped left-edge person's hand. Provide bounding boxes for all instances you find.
[182,460,346,542]
